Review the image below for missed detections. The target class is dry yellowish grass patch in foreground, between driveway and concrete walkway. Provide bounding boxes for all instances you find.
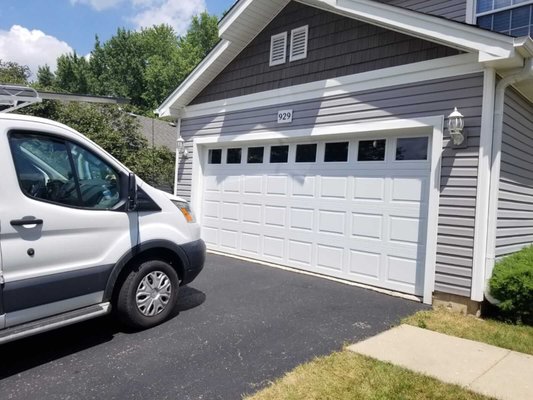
[245,351,488,400]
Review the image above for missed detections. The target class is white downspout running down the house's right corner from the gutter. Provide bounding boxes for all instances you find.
[485,58,533,303]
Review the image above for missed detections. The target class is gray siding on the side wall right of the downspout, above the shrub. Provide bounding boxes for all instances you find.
[496,89,533,257]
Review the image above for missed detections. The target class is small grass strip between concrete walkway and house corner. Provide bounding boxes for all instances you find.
[402,309,533,355]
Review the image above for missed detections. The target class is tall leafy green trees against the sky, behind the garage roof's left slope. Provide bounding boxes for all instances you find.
[39,12,218,115]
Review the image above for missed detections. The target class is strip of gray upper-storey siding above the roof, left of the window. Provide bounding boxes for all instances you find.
[376,0,466,22]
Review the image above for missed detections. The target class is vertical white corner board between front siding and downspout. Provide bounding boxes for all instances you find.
[467,68,496,301]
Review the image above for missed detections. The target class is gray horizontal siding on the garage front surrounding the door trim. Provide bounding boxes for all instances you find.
[178,74,483,296]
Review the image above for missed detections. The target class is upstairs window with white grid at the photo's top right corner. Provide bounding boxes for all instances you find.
[476,0,533,36]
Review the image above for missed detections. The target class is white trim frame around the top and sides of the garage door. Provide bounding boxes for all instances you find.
[191,115,444,304]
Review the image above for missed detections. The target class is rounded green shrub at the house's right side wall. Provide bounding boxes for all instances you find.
[489,246,533,323]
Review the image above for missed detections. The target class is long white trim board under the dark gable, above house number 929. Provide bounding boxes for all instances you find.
[181,54,483,118]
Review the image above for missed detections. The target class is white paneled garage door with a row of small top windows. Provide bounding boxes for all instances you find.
[200,136,431,295]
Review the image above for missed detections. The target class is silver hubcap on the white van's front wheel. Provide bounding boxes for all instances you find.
[135,271,172,317]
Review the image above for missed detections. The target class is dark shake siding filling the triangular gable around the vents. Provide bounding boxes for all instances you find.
[191,2,459,104]
